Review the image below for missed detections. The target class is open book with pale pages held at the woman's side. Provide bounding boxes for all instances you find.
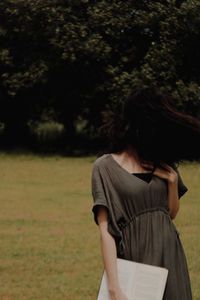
[97,257,168,300]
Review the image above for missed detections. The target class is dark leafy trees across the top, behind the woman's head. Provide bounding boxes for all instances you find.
[0,0,200,154]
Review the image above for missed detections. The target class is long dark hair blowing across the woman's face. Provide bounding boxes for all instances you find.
[98,87,200,167]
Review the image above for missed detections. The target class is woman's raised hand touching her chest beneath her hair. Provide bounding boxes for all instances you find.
[142,163,178,183]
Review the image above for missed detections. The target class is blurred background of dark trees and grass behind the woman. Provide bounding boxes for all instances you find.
[0,0,200,300]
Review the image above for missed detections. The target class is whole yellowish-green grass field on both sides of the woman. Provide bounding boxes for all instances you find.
[0,153,200,300]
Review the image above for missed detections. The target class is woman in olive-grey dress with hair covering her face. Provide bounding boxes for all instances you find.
[92,87,200,300]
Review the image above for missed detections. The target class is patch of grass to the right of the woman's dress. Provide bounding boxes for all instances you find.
[174,163,200,300]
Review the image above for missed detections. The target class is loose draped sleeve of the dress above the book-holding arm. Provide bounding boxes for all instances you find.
[91,164,124,255]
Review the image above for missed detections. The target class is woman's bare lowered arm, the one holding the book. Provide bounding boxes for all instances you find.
[97,206,128,300]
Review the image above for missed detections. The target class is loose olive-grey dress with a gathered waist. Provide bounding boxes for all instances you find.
[91,154,192,300]
